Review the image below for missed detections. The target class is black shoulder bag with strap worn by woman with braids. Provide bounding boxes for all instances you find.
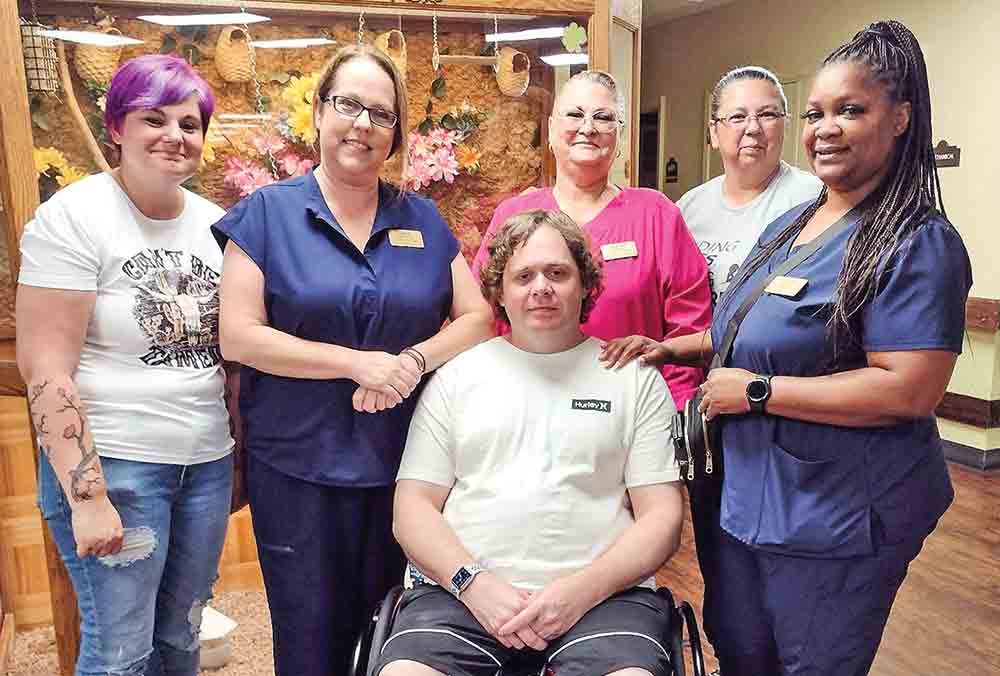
[670,209,858,495]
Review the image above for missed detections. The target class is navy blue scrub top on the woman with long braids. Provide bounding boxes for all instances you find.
[712,204,972,558]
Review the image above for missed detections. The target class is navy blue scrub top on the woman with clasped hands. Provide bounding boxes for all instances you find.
[214,172,459,487]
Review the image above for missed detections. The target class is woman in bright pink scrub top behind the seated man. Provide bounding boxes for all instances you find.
[473,71,712,408]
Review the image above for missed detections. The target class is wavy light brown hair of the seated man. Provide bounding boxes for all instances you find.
[479,209,603,324]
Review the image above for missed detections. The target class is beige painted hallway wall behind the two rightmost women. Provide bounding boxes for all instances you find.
[642,0,1000,448]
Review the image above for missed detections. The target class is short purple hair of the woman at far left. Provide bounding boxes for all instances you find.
[104,54,215,133]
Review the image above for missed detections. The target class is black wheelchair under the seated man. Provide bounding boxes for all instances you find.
[347,586,705,676]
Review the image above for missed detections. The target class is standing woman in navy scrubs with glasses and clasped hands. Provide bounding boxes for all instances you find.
[215,45,492,676]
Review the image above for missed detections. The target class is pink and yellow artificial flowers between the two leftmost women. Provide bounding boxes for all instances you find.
[219,73,320,198]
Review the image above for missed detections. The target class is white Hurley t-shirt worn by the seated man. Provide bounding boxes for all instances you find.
[398,338,680,589]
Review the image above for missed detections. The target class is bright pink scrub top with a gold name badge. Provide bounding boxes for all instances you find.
[472,188,712,408]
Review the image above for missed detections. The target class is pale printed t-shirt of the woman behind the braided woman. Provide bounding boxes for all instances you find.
[677,162,823,306]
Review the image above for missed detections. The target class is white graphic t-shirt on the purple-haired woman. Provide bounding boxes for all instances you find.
[18,174,233,465]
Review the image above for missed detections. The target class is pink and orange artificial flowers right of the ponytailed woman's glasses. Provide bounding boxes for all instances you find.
[403,101,486,191]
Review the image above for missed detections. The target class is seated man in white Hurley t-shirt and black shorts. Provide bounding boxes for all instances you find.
[370,211,682,676]
